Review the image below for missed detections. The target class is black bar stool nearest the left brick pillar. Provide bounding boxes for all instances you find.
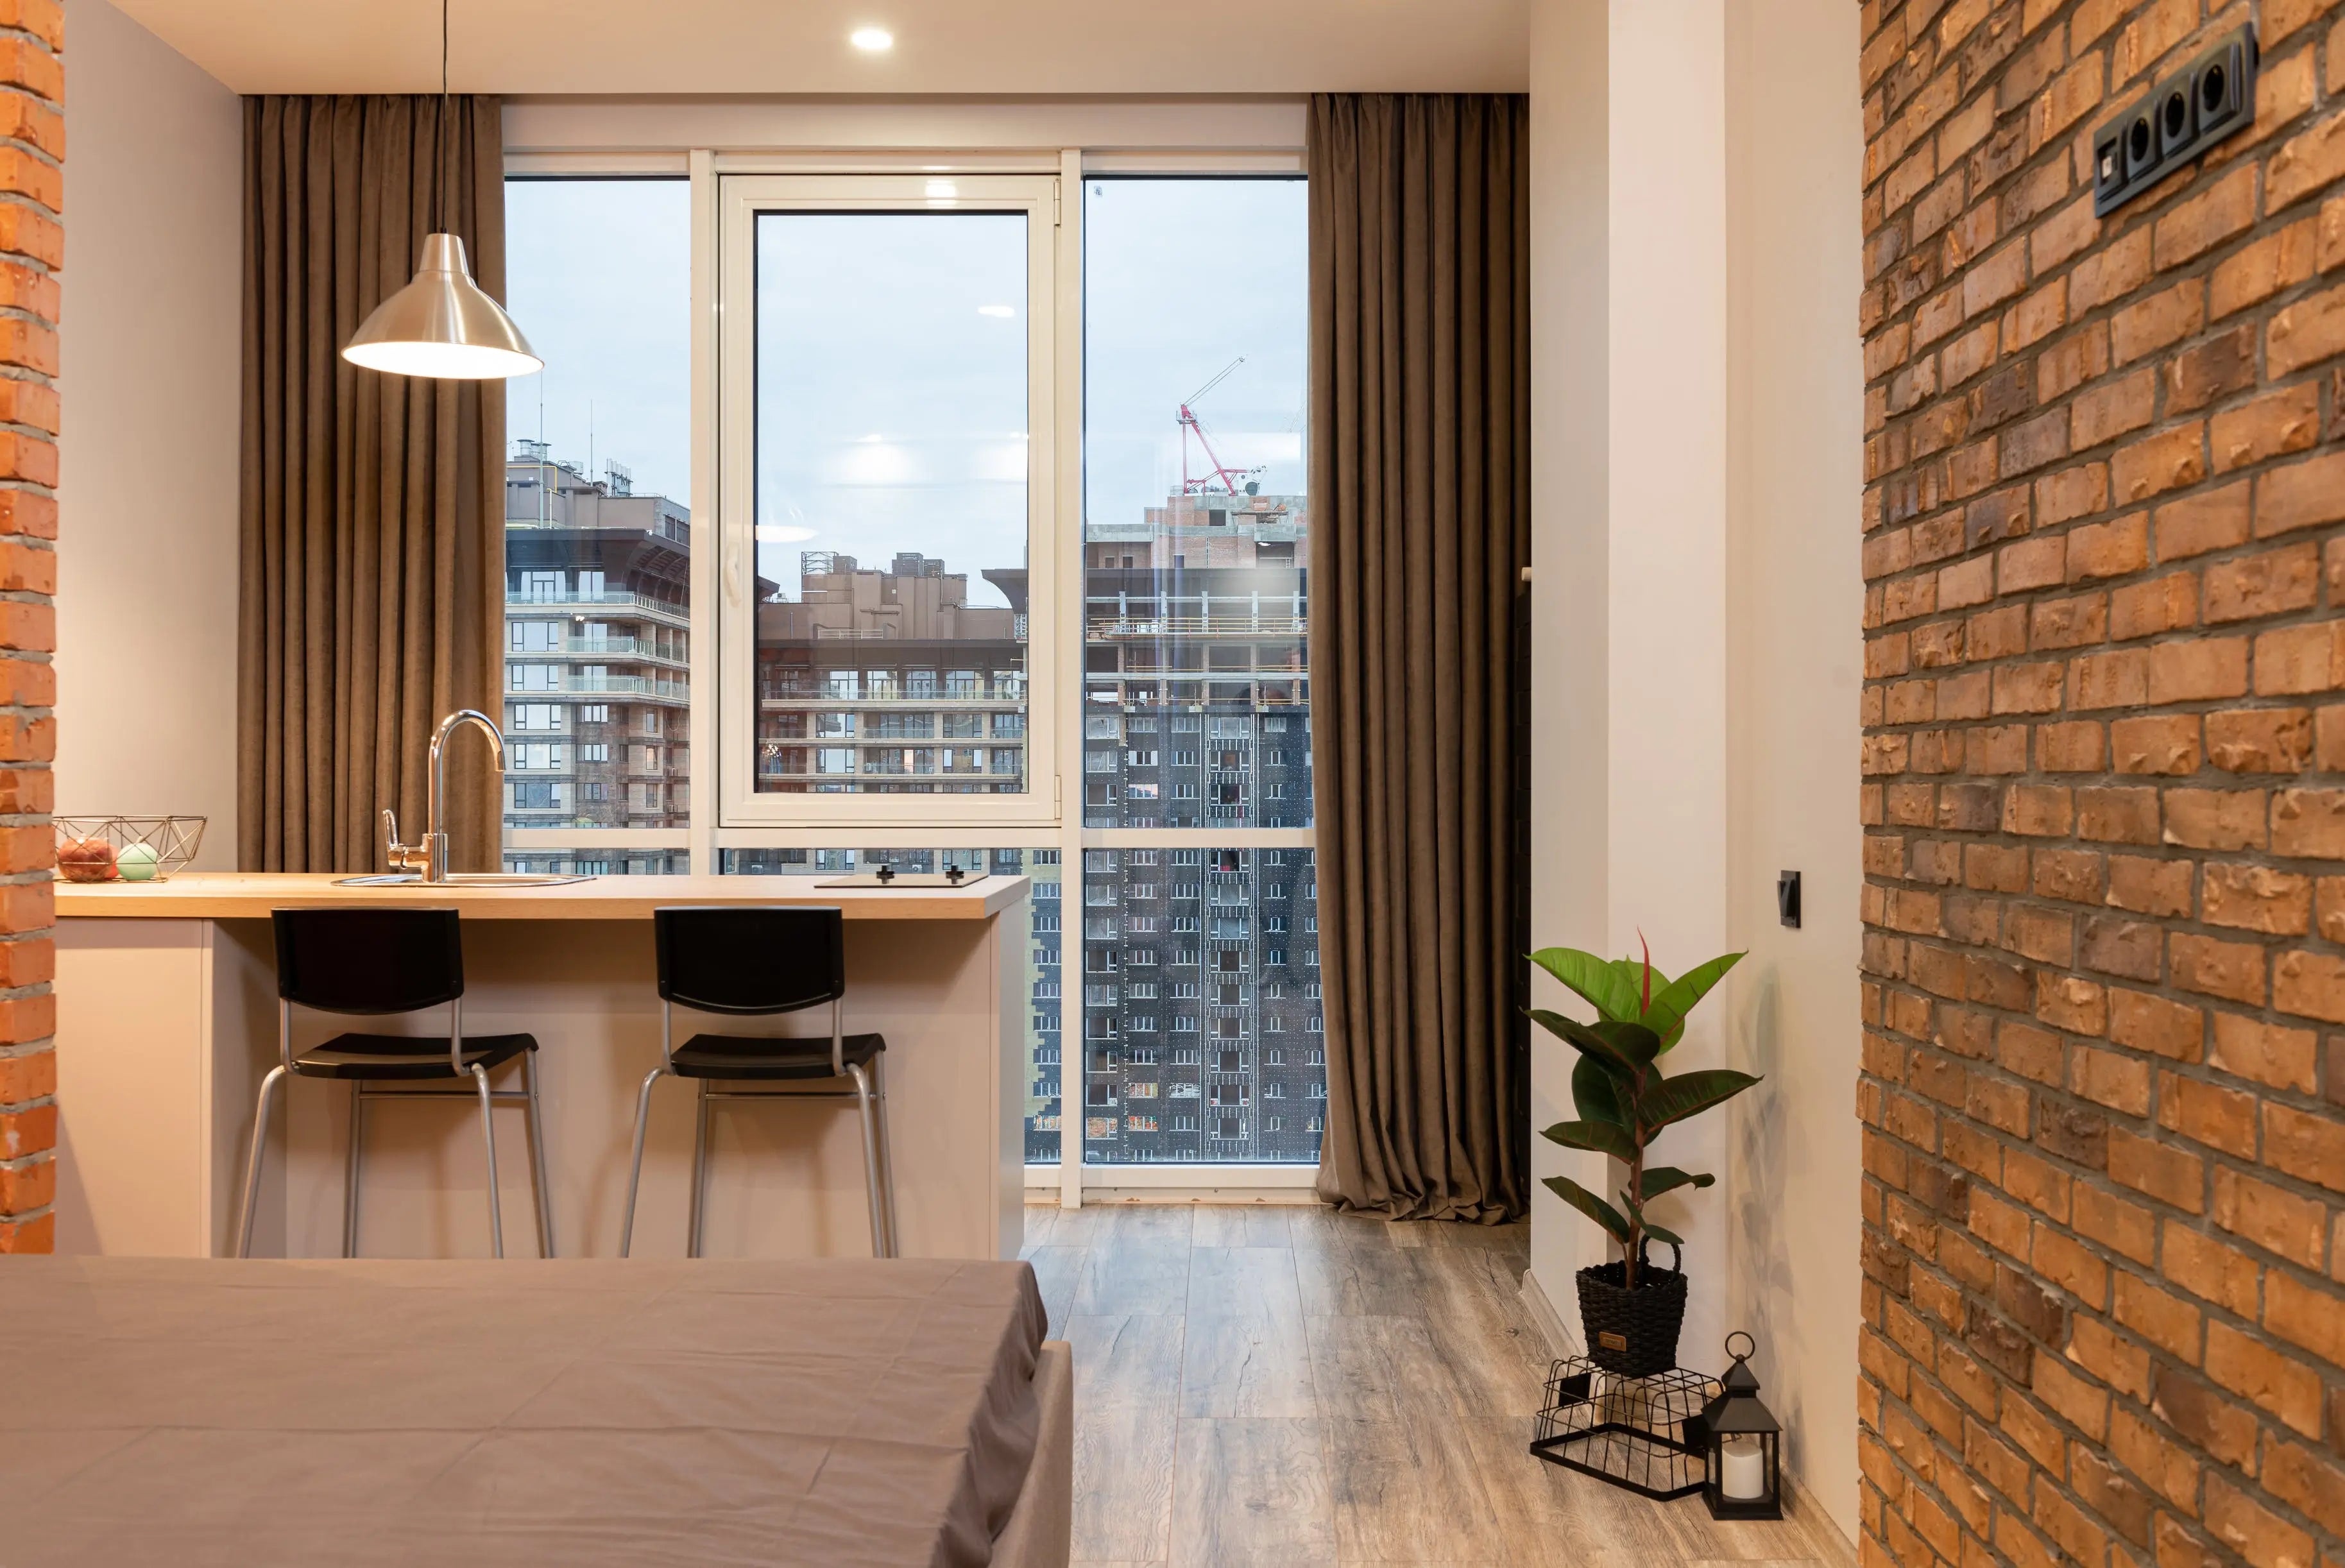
[237,909,554,1259]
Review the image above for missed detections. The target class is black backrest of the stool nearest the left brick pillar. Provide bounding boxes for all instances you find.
[272,909,465,1012]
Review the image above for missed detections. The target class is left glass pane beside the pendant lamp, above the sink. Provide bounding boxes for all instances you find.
[504,180,692,858]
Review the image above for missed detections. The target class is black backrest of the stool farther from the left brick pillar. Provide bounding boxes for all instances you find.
[652,907,846,1012]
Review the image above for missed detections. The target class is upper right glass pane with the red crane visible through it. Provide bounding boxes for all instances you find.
[1084,180,1311,828]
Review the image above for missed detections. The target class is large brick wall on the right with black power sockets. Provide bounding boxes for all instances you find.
[1859,0,2345,1568]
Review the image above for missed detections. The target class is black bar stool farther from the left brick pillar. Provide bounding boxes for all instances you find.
[619,907,896,1259]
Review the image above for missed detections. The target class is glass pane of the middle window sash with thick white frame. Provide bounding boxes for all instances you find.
[755,213,1027,794]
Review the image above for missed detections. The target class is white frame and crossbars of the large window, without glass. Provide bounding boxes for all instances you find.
[504,148,1318,1207]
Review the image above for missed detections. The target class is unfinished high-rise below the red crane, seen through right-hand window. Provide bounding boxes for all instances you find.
[1070,495,1327,1163]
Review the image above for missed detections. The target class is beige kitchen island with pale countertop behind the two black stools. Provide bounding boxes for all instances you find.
[56,874,1030,1259]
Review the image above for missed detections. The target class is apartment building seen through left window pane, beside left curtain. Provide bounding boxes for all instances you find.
[504,441,692,874]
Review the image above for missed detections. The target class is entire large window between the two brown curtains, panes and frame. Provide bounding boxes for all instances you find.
[506,159,1325,1191]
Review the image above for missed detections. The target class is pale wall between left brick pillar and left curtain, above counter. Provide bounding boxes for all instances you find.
[56,0,244,869]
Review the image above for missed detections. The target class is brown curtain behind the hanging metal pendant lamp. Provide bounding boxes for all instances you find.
[237,96,504,872]
